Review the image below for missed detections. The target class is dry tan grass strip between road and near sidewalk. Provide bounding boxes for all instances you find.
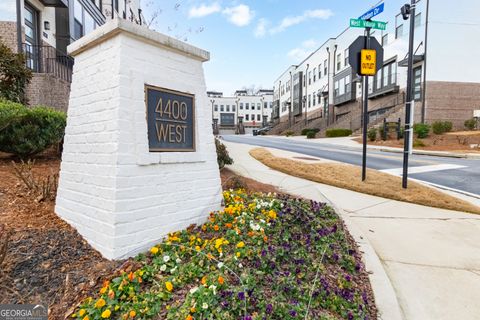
[250,148,480,214]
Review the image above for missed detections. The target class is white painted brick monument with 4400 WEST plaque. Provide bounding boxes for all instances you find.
[55,20,221,259]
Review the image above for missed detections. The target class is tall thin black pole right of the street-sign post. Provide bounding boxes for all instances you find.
[400,0,416,189]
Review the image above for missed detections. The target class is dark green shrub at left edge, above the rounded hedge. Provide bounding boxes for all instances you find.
[0,42,32,103]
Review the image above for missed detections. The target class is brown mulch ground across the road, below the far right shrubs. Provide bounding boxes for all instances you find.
[355,131,480,153]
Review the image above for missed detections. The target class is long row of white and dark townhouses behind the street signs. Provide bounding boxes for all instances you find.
[272,0,480,130]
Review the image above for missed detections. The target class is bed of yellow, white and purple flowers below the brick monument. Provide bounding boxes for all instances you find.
[72,191,376,320]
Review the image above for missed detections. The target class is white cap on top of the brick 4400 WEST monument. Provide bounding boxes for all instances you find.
[67,18,210,62]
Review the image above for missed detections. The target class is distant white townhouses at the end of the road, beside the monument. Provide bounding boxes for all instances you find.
[207,89,273,133]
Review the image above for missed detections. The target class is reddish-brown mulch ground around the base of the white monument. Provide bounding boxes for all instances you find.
[0,153,278,319]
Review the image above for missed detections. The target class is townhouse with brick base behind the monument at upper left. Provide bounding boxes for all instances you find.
[0,0,143,110]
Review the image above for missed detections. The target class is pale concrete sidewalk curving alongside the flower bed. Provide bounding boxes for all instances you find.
[225,142,480,320]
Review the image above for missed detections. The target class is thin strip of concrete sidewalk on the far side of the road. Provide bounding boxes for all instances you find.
[269,136,480,159]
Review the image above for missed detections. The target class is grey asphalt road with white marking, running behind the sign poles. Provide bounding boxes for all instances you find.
[222,135,480,198]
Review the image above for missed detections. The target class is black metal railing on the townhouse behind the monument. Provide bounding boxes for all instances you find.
[22,43,73,82]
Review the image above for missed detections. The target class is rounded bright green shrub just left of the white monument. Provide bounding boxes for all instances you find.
[0,100,67,158]
